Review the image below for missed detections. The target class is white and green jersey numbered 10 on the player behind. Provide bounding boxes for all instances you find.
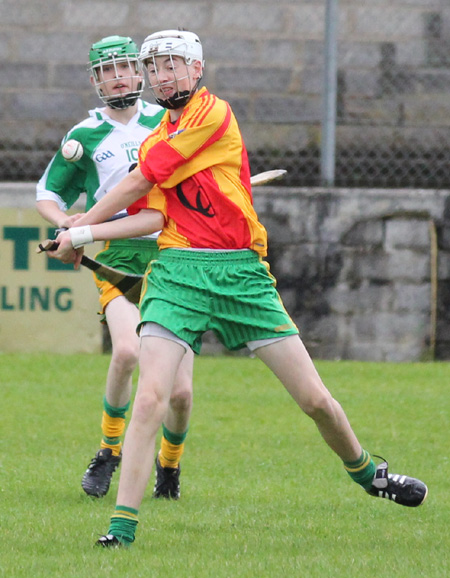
[36,99,165,232]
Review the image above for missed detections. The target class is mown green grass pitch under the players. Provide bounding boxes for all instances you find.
[0,355,450,578]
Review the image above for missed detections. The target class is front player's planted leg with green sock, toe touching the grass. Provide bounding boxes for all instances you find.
[98,336,186,546]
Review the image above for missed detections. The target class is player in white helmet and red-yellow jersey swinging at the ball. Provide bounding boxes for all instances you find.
[54,30,427,547]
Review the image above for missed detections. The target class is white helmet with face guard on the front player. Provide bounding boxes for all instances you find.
[139,30,204,110]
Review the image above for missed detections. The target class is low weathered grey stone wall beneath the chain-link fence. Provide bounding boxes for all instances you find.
[4,183,450,361]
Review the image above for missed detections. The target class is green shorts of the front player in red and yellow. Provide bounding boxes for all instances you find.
[140,249,298,353]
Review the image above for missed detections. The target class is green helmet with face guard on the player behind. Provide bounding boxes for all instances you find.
[88,36,144,109]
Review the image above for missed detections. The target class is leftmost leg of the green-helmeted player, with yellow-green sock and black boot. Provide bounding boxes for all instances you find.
[81,295,139,497]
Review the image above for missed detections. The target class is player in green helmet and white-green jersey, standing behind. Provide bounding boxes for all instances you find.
[36,36,193,499]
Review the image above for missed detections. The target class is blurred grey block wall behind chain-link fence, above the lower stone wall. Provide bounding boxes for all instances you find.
[0,0,450,188]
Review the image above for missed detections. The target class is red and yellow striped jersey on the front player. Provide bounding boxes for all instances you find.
[129,88,267,256]
